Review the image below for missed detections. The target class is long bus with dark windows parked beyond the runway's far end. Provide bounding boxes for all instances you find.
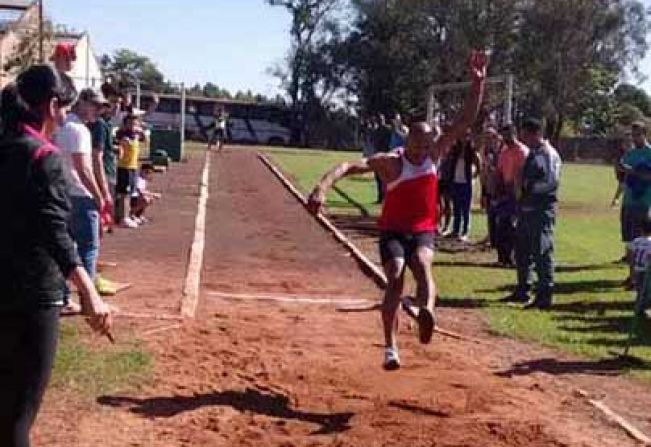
[140,93,294,146]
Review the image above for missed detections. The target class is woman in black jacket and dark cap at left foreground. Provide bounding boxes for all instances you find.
[0,65,111,447]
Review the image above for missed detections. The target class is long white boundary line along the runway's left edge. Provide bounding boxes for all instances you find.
[181,150,211,318]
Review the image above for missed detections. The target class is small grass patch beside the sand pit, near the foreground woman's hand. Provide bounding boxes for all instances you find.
[52,322,152,397]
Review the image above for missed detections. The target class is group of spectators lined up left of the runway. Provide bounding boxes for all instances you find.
[0,44,160,447]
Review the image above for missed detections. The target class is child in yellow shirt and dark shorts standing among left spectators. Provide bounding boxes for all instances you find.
[116,114,146,228]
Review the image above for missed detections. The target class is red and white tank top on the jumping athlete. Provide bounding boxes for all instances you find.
[378,150,438,233]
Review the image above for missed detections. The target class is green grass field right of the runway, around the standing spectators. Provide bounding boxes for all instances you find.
[270,149,651,380]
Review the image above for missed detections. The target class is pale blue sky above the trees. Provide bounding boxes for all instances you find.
[44,0,651,96]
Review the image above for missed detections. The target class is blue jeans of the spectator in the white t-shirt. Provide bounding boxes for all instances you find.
[70,196,99,279]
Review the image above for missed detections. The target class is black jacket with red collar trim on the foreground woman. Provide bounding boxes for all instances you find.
[0,128,80,312]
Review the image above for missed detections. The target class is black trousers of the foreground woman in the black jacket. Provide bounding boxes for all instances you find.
[0,307,60,447]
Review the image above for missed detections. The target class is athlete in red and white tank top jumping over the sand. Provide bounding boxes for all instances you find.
[308,52,487,370]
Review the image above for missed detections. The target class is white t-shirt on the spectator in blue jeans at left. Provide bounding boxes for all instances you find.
[54,112,93,197]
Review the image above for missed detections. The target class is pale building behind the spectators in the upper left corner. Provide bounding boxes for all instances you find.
[0,0,102,90]
